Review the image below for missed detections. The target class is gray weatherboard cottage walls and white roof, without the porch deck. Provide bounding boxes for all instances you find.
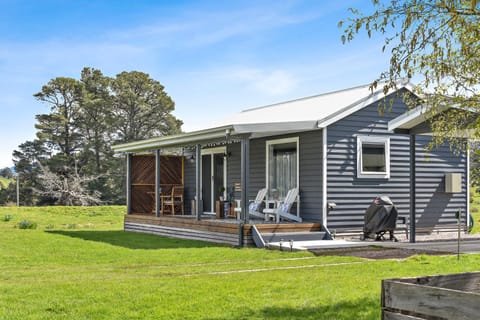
[114,83,469,241]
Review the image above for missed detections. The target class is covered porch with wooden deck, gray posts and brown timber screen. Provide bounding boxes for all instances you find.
[115,122,325,246]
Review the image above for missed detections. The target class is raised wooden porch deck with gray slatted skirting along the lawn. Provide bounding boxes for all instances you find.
[124,214,321,246]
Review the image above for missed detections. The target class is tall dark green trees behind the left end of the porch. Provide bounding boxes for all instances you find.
[7,68,182,205]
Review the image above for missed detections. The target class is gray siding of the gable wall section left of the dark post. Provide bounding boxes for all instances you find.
[327,92,410,229]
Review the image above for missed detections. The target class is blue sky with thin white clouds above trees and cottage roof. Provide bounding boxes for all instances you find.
[0,0,388,167]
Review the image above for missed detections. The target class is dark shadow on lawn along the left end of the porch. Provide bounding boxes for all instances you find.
[45,230,223,249]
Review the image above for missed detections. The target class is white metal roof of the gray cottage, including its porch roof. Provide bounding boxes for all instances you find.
[113,82,413,152]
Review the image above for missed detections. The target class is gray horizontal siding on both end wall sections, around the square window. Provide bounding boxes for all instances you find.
[327,90,467,230]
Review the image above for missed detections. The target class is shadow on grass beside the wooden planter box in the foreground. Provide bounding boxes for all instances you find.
[215,298,381,320]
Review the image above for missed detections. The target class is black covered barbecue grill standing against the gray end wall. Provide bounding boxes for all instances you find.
[363,195,398,241]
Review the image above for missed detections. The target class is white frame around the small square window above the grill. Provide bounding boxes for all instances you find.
[357,136,390,179]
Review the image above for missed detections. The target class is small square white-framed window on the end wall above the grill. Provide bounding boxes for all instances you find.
[357,136,390,179]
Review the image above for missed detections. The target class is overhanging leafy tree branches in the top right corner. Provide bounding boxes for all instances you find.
[339,0,480,149]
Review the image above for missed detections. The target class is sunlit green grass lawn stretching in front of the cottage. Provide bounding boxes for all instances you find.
[0,207,480,319]
